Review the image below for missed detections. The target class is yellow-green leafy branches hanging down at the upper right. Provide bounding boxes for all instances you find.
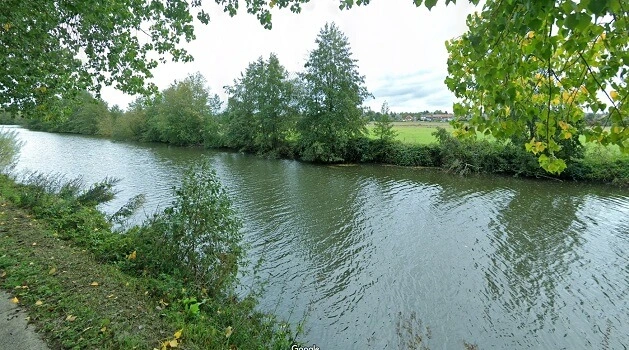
[446,0,629,173]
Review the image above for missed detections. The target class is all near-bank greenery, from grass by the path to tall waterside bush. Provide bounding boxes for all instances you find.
[0,129,297,349]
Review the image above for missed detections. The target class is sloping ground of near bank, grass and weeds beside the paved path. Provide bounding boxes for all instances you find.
[0,176,294,349]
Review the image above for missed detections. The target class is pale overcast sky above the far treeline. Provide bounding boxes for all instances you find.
[103,0,480,112]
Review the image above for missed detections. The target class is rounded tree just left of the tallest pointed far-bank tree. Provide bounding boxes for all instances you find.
[227,53,297,153]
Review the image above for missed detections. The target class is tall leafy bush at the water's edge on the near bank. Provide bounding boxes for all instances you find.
[134,162,244,295]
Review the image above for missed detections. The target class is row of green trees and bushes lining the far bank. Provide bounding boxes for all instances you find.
[6,24,629,183]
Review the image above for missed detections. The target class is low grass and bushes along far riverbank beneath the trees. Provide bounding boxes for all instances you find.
[6,117,629,186]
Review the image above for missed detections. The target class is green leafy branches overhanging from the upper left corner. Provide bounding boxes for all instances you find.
[0,0,334,119]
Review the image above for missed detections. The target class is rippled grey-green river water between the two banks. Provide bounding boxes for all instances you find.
[6,128,629,349]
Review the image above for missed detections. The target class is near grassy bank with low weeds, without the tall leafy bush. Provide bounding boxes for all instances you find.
[0,175,294,349]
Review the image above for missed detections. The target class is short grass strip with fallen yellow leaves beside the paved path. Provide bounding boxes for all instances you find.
[0,198,169,349]
